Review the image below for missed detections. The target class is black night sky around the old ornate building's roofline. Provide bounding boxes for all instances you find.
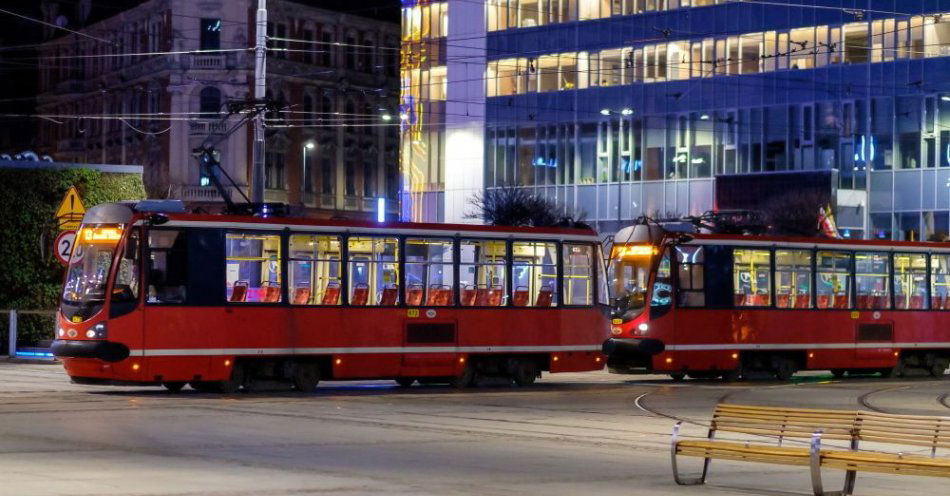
[0,0,400,151]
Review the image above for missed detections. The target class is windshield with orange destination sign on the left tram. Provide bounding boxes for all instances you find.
[63,224,123,319]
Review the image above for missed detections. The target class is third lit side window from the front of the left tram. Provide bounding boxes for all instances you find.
[347,236,399,306]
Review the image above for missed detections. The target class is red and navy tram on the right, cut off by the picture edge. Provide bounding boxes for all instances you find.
[604,224,950,380]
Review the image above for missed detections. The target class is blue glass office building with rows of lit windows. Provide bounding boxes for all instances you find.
[401,0,950,239]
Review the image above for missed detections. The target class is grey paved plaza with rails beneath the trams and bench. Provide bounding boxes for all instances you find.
[0,362,950,496]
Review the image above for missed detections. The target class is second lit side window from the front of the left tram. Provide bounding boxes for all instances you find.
[288,234,340,305]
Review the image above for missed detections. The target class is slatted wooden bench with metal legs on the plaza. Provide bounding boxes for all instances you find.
[671,404,950,496]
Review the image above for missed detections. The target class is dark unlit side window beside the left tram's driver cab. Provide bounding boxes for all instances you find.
[148,229,188,304]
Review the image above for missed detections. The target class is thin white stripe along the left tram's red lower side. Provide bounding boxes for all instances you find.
[130,345,600,357]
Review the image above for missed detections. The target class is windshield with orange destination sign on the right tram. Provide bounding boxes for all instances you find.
[608,245,657,320]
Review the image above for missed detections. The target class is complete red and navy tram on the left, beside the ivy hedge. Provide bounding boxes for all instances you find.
[53,201,609,391]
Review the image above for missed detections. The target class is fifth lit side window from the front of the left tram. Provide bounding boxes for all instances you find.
[459,240,507,307]
